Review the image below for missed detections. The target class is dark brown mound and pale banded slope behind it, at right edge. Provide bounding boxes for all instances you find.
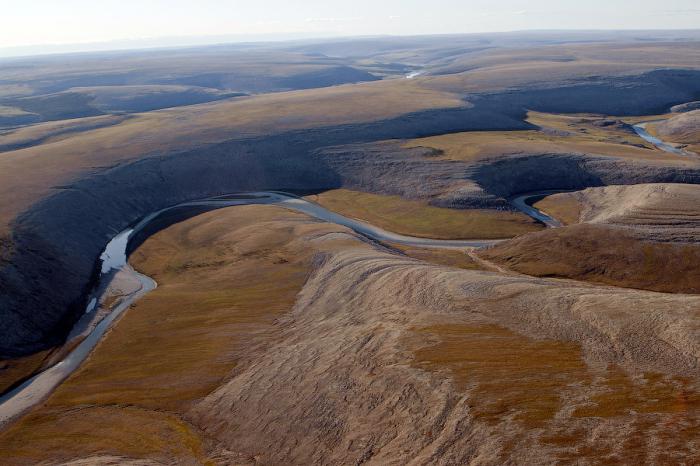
[481,184,700,293]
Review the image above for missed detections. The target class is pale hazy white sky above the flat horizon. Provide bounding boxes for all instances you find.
[0,0,700,55]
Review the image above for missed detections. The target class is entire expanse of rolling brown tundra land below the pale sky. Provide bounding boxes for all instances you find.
[0,38,700,466]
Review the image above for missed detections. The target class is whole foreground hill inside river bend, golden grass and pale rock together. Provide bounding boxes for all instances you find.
[0,206,700,464]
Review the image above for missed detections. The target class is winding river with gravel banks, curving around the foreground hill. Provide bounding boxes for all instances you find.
[0,192,548,426]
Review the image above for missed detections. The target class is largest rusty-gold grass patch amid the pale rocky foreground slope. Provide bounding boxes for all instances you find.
[415,324,589,427]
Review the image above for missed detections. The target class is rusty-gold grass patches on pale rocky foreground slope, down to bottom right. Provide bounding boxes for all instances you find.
[411,324,700,464]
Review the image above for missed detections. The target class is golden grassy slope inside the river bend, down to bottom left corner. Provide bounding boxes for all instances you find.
[0,206,330,464]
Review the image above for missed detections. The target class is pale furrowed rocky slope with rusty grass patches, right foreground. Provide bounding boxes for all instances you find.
[185,228,698,464]
